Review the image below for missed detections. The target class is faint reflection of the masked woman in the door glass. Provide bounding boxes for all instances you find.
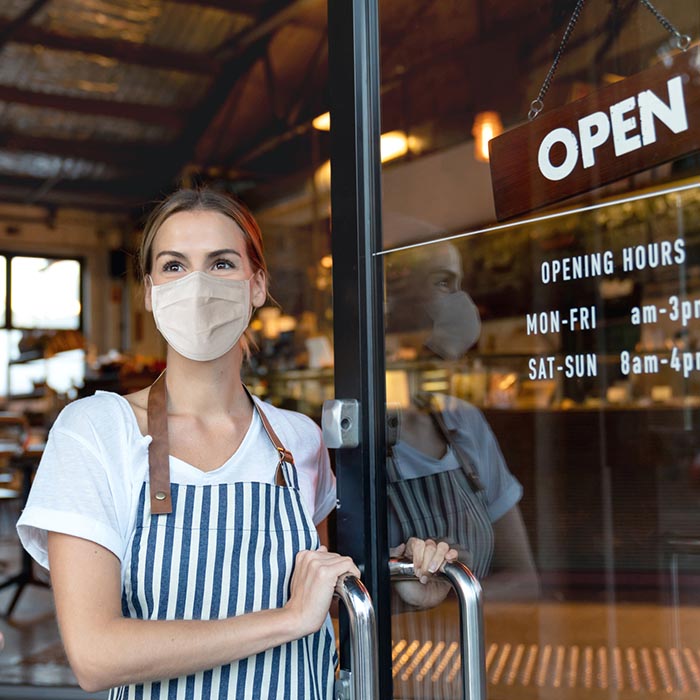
[387,244,537,607]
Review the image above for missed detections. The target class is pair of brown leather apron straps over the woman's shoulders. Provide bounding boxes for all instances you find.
[148,371,294,515]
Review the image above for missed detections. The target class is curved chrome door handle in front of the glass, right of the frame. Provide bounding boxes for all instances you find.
[389,559,486,700]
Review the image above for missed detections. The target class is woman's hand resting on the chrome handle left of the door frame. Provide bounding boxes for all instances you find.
[284,546,360,637]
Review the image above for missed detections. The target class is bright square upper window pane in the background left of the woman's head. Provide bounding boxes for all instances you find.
[10,257,80,329]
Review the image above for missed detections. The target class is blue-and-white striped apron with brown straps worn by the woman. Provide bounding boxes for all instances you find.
[110,374,335,700]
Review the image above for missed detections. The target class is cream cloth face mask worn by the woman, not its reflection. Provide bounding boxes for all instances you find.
[151,272,253,362]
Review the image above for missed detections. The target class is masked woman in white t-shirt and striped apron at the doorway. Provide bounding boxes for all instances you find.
[18,190,454,699]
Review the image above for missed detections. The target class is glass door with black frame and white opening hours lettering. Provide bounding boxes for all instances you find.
[329,0,700,699]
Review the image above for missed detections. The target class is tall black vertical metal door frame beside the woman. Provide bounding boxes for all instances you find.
[328,0,392,698]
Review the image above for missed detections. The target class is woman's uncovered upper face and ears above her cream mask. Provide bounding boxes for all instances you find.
[145,211,266,311]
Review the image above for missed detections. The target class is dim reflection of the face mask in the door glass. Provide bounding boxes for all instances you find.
[425,291,481,360]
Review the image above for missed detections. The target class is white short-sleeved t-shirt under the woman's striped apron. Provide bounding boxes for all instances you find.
[17,391,335,568]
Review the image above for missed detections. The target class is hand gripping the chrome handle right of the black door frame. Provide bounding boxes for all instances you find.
[389,537,459,608]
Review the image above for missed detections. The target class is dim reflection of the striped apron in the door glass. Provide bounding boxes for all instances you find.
[387,457,493,578]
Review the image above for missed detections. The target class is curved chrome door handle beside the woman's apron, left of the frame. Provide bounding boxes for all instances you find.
[334,574,379,700]
